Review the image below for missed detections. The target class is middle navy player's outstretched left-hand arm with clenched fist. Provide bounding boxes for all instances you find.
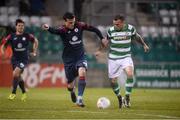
[42,24,61,35]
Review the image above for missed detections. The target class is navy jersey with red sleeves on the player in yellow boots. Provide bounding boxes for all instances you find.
[2,33,35,61]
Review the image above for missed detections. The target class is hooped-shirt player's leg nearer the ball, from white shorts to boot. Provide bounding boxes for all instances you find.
[108,60,122,108]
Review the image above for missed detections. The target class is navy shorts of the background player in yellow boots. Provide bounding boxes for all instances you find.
[12,61,28,71]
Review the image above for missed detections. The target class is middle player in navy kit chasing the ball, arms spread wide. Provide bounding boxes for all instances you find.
[42,12,103,107]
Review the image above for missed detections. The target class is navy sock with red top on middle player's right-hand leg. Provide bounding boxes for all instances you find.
[78,76,86,96]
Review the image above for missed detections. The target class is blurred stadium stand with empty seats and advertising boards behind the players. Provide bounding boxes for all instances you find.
[0,0,180,88]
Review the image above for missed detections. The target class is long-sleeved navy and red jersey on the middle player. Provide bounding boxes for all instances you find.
[48,22,103,64]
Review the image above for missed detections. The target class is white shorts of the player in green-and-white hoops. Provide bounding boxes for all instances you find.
[108,57,134,78]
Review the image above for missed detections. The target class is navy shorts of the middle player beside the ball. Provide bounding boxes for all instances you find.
[64,60,87,83]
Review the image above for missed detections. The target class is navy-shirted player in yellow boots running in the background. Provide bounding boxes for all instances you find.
[1,19,38,101]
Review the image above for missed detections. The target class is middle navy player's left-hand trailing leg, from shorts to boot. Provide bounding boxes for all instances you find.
[64,65,77,103]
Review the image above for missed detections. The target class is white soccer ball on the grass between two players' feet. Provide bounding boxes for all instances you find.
[97,97,111,109]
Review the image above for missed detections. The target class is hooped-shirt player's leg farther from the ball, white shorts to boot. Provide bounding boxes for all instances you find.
[124,58,134,107]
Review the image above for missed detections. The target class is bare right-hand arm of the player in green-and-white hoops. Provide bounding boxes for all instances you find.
[134,33,149,52]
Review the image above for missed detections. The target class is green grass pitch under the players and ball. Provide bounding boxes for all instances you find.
[0,88,180,119]
